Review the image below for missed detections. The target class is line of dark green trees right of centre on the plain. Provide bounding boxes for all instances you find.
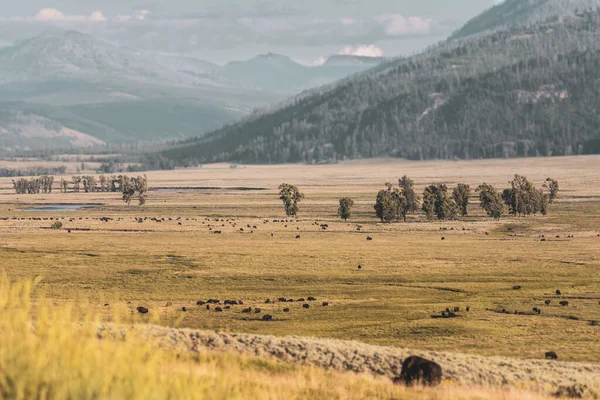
[279,174,560,222]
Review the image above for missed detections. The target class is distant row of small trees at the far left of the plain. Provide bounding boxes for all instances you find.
[12,175,148,205]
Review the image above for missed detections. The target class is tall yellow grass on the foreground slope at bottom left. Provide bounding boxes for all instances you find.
[0,276,572,400]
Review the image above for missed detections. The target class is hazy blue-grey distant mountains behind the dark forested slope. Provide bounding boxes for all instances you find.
[0,31,381,150]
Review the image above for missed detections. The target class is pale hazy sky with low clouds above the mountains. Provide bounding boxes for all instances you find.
[0,0,495,63]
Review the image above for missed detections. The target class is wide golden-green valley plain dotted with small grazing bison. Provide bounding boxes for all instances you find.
[0,157,600,398]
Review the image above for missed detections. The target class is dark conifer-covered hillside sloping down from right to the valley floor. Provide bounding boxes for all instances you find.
[163,11,600,164]
